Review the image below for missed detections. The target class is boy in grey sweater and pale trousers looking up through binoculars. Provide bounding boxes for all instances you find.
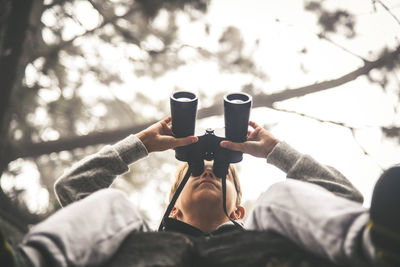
[1,117,400,266]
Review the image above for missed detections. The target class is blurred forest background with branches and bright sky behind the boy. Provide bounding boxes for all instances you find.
[0,0,400,229]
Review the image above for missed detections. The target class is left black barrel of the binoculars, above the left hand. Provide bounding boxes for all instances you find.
[170,91,198,138]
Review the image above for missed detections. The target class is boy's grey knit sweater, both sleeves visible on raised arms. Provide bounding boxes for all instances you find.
[55,135,363,206]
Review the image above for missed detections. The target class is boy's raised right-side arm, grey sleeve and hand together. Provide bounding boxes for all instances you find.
[221,122,363,202]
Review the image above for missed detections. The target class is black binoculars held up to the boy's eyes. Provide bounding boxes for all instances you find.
[170,91,252,178]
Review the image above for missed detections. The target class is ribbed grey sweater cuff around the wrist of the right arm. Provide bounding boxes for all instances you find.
[267,142,302,173]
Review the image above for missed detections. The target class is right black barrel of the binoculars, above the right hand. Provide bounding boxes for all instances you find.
[224,93,252,142]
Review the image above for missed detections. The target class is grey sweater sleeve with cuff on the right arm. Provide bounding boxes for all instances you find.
[267,142,364,203]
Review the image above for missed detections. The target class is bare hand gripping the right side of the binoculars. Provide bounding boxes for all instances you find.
[220,121,279,158]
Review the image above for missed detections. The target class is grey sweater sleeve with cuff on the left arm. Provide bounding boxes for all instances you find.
[54,135,148,207]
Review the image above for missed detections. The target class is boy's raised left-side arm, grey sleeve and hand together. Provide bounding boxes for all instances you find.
[54,117,197,206]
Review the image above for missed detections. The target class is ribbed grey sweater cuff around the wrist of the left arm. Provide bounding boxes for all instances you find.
[113,134,149,165]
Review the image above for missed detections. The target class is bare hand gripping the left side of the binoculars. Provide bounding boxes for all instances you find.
[136,116,198,153]
